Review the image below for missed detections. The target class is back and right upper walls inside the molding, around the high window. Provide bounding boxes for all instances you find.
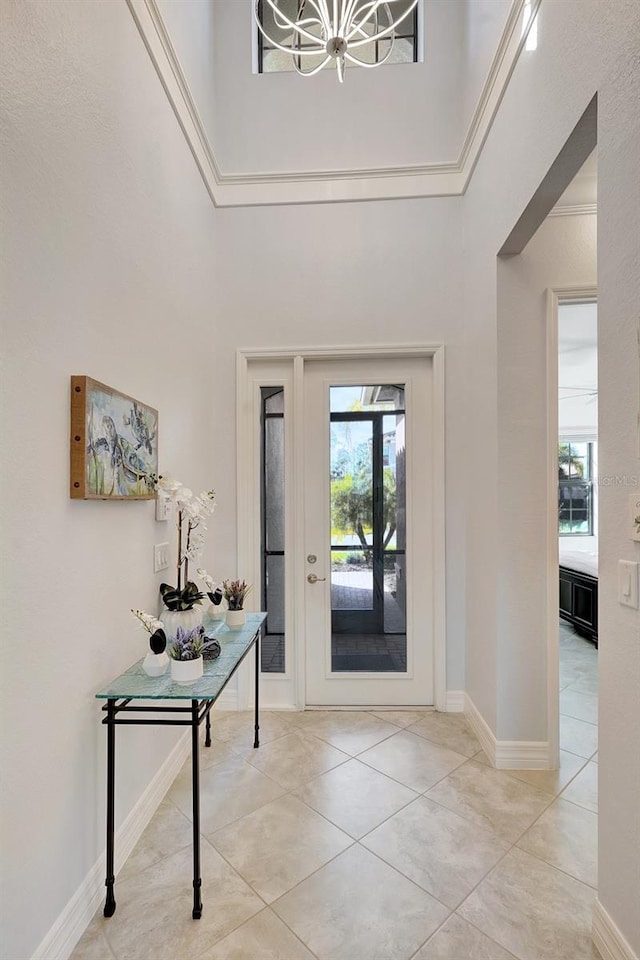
[202,0,511,175]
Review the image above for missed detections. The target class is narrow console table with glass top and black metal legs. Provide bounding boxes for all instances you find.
[96,613,267,920]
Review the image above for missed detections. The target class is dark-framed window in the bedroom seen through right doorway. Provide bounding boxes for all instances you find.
[558,440,595,537]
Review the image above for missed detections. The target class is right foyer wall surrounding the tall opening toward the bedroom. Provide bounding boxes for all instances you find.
[465,0,640,952]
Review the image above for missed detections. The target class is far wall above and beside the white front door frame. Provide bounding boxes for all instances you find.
[211,199,469,690]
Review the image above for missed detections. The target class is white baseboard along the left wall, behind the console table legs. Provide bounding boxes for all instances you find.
[31,732,191,960]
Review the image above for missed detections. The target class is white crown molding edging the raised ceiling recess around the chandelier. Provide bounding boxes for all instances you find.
[126,0,541,207]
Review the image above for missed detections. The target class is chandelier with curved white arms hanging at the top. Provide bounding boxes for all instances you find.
[253,0,418,83]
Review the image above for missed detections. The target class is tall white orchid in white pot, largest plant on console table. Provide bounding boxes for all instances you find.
[157,477,216,639]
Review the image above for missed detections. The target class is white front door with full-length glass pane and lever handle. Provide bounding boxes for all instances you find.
[304,359,433,705]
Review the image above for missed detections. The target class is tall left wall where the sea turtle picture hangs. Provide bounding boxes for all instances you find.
[0,0,220,960]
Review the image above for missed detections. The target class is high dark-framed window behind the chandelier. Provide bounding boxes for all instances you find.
[256,0,420,73]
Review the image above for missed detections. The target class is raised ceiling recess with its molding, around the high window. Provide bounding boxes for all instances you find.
[140,0,539,206]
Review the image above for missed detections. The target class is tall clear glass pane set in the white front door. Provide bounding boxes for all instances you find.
[329,384,407,673]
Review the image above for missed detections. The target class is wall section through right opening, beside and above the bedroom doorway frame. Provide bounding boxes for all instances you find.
[496,215,596,741]
